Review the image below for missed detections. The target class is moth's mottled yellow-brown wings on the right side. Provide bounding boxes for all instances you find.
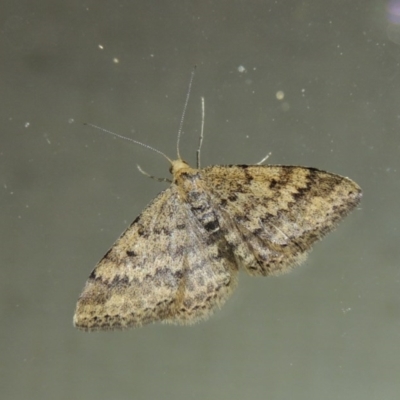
[202,165,361,275]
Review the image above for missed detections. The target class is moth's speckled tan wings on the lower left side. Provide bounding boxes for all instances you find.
[74,185,235,330]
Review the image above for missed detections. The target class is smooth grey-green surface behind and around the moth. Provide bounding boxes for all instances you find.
[0,0,400,400]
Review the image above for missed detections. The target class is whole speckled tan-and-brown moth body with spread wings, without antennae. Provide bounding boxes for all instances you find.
[74,160,361,331]
